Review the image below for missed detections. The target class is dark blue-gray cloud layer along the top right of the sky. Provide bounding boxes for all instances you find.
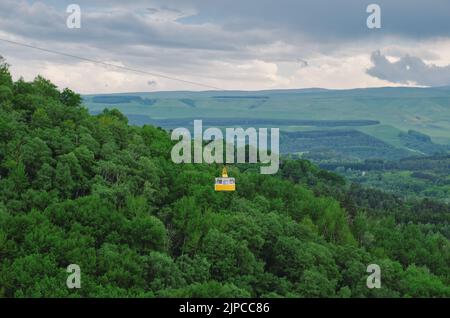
[156,0,450,40]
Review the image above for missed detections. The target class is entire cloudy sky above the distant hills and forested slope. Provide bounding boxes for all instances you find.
[0,0,450,93]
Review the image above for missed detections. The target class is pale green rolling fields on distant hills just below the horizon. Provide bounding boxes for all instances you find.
[84,87,450,160]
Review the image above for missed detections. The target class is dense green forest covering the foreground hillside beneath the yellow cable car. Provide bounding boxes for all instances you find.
[0,65,450,297]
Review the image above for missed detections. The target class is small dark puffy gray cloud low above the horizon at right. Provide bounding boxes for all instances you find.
[367,51,450,86]
